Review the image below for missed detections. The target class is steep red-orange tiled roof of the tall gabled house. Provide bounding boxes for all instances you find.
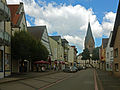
[8,4,20,25]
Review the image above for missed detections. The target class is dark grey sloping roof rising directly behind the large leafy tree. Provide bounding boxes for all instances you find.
[27,26,46,40]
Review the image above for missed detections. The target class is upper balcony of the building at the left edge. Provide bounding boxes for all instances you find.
[0,0,11,21]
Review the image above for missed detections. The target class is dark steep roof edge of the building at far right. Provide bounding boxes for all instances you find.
[110,1,120,47]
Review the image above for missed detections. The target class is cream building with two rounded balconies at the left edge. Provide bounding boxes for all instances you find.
[0,0,11,78]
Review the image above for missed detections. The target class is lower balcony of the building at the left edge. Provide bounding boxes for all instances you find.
[0,32,11,45]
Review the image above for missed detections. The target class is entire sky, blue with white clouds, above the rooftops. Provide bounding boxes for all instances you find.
[7,0,119,53]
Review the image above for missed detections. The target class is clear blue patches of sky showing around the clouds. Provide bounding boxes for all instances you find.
[26,0,119,52]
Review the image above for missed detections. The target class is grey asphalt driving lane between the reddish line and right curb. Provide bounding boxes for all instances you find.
[45,69,95,90]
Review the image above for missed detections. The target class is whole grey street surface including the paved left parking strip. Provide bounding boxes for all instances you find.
[0,69,95,90]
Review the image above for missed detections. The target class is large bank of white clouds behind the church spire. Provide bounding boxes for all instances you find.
[7,0,115,50]
